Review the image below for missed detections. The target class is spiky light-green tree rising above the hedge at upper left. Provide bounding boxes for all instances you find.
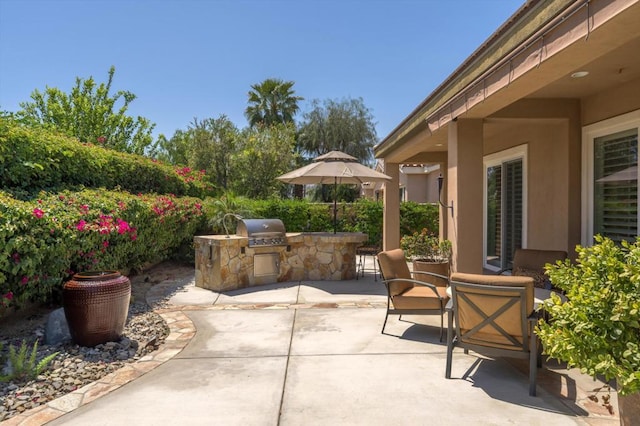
[17,66,155,154]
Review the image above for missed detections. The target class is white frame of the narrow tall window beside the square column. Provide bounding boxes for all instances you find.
[482,144,529,271]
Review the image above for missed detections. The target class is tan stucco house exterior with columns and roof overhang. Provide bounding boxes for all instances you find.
[375,0,640,272]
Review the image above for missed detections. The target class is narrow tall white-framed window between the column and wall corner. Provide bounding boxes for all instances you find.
[484,145,527,270]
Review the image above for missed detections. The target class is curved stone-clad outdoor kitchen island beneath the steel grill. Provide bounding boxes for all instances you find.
[194,232,367,291]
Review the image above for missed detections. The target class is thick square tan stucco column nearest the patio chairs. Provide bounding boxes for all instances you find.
[442,119,484,273]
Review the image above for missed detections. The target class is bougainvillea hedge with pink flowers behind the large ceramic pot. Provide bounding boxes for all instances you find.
[0,190,205,307]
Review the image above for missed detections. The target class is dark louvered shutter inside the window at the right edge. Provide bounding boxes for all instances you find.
[593,128,638,242]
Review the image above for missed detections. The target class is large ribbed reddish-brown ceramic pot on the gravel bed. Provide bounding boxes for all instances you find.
[62,271,131,346]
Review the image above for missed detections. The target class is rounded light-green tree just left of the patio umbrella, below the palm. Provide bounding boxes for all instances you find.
[230,124,297,198]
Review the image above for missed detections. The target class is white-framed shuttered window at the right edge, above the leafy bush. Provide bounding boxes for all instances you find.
[582,111,640,245]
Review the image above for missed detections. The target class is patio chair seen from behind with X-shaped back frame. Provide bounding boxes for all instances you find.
[445,272,541,396]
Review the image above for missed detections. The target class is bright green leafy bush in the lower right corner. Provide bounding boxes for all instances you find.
[537,236,640,395]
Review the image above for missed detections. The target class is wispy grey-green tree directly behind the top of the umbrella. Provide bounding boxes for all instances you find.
[298,98,377,164]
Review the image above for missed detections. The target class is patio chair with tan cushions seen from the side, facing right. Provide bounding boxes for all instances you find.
[378,249,449,341]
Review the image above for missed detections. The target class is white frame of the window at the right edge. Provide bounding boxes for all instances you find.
[581,110,640,246]
